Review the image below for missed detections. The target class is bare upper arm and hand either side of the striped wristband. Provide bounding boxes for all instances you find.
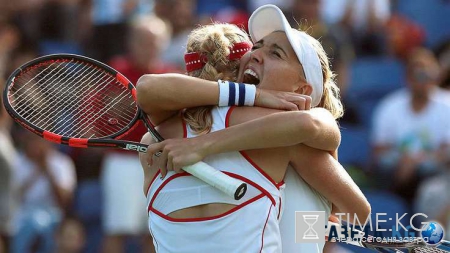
[136,74,311,125]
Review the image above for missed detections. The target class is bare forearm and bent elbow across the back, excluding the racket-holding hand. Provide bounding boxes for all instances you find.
[195,108,340,155]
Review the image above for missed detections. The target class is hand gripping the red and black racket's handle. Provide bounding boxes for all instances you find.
[147,137,207,178]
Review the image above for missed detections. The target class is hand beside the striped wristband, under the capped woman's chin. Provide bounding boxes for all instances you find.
[255,89,311,111]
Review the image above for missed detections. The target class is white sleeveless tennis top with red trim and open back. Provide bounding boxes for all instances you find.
[147,107,284,253]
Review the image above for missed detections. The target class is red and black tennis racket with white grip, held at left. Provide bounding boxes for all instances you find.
[3,54,247,200]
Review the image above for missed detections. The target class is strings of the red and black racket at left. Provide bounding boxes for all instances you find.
[9,60,137,138]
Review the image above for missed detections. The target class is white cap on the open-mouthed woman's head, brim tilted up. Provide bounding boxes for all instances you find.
[248,4,323,106]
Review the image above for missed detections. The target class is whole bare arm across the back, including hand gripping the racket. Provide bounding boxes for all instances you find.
[148,108,340,173]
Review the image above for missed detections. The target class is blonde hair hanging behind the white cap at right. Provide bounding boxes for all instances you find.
[311,36,344,119]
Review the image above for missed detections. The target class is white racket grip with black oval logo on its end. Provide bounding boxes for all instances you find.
[183,162,247,200]
